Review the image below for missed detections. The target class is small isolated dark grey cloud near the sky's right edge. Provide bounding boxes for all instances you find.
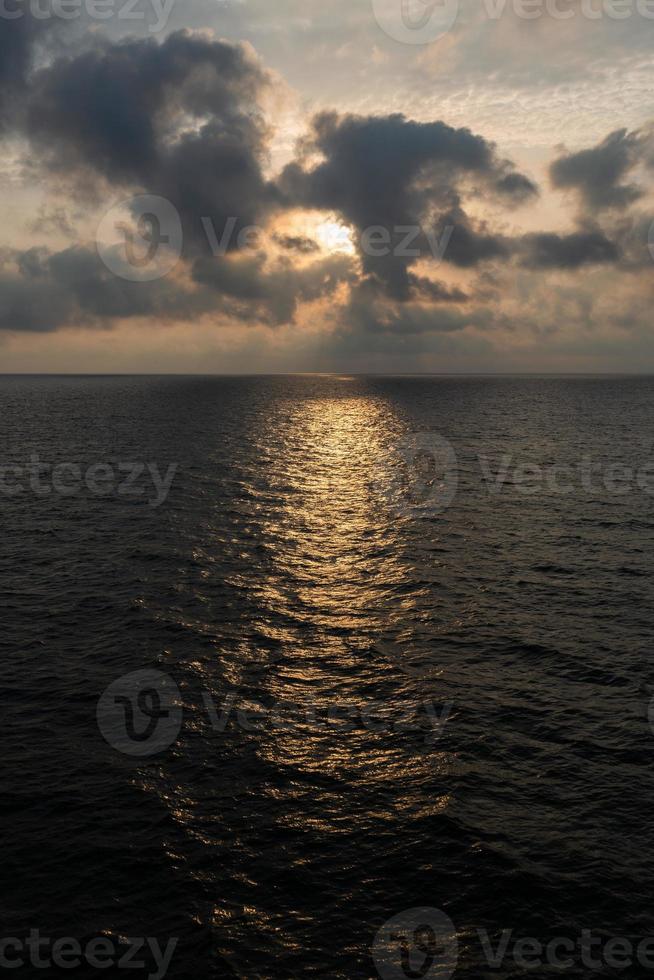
[550,129,644,211]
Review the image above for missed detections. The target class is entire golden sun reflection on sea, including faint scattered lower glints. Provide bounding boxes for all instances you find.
[136,376,454,975]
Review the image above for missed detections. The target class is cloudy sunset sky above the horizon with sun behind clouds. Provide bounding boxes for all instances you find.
[0,0,654,374]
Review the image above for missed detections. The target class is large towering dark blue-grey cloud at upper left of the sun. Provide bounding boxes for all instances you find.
[26,32,275,253]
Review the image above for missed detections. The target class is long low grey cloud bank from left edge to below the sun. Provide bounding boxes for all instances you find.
[0,246,355,332]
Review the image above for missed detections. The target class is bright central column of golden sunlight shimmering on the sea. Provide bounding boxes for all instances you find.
[249,377,454,796]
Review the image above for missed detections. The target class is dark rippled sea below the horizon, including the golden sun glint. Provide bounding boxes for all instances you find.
[0,377,654,980]
